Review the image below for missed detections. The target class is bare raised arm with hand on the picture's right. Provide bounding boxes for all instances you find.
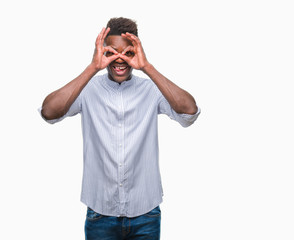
[119,33,198,114]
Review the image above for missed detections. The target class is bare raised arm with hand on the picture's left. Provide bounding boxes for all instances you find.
[42,28,118,120]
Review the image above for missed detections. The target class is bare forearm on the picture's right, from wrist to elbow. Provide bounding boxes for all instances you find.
[142,64,198,114]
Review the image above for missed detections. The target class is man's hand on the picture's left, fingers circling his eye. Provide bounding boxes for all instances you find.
[92,28,119,71]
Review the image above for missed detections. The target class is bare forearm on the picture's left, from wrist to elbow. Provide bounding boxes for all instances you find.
[42,64,98,120]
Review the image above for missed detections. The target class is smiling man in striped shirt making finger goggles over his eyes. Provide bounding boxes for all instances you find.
[40,18,200,240]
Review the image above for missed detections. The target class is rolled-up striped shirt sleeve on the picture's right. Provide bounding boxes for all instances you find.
[158,91,201,127]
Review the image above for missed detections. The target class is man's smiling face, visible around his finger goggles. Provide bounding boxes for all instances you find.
[104,35,133,83]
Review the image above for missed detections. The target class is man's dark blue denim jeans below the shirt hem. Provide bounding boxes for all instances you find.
[85,206,161,240]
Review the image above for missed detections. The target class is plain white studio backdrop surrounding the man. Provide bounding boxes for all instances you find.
[0,0,294,240]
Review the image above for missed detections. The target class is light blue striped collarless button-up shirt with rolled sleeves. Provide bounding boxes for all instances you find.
[40,74,200,217]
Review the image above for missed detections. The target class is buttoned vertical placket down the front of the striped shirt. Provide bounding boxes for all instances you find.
[117,86,126,216]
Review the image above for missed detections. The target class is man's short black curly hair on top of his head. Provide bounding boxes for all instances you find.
[106,17,138,37]
